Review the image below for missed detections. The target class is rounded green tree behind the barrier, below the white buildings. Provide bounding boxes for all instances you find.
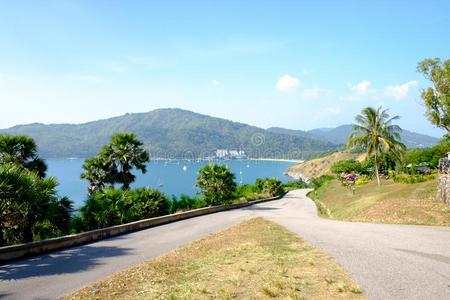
[196,164,236,205]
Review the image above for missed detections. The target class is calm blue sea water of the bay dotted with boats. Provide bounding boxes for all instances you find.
[47,159,293,207]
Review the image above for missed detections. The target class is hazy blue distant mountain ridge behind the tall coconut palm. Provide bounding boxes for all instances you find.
[267,124,439,148]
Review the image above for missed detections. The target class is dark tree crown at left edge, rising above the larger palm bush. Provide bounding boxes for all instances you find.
[0,135,47,178]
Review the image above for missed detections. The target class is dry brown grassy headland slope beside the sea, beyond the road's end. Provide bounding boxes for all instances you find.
[288,150,365,179]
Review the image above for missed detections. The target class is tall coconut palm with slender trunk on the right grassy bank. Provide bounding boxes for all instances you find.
[347,106,406,186]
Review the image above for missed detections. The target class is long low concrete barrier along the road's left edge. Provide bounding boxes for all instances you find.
[0,196,282,263]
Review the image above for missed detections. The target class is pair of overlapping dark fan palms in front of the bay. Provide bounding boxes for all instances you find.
[81,132,150,193]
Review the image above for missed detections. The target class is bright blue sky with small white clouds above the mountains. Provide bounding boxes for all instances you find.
[0,0,450,137]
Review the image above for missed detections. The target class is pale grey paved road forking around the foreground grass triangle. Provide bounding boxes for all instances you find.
[0,190,450,300]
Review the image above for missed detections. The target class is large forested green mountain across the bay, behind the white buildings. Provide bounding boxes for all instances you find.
[0,109,336,159]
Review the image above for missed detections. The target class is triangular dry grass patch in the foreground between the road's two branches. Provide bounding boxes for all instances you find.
[66,218,365,299]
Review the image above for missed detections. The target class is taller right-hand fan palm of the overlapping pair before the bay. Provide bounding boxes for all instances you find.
[107,132,150,190]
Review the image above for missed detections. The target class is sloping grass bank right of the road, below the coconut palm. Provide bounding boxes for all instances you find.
[310,180,450,226]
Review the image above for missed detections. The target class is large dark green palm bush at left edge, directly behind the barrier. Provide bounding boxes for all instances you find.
[0,164,72,244]
